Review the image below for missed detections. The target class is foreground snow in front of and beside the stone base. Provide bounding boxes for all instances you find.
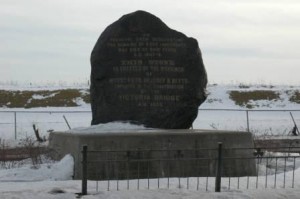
[0,150,300,199]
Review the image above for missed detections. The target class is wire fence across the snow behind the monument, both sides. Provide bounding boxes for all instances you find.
[0,109,300,139]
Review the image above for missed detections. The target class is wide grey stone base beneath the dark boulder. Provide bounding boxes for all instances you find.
[49,129,256,180]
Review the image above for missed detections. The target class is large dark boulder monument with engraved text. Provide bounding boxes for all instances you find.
[91,11,207,129]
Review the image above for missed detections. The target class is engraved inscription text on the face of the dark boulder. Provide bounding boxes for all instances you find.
[107,34,189,107]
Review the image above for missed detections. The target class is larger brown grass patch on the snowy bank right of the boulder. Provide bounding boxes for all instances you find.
[229,90,280,108]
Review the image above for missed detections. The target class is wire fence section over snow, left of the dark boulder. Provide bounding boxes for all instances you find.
[0,111,92,139]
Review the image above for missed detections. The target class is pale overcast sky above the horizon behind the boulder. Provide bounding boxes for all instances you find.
[0,0,300,84]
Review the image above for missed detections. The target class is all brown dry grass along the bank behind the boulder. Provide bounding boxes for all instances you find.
[0,88,300,108]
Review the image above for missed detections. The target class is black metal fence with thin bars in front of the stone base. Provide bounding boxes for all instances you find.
[82,143,300,194]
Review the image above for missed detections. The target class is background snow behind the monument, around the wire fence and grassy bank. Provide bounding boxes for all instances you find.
[0,85,300,140]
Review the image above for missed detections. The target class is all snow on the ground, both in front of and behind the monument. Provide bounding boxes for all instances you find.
[0,86,300,199]
